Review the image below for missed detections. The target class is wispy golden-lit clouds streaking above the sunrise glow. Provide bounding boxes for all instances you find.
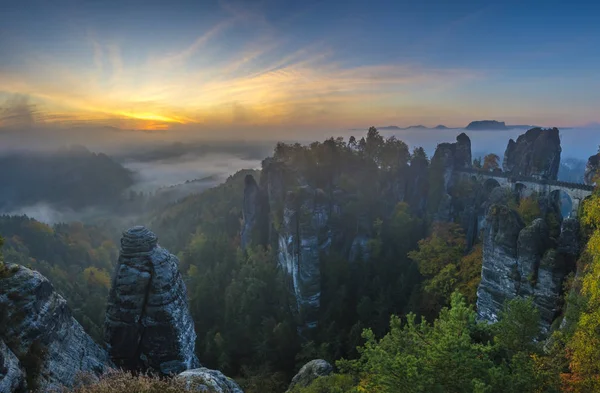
[0,3,481,129]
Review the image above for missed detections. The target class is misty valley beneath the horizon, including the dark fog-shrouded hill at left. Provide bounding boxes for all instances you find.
[0,128,600,224]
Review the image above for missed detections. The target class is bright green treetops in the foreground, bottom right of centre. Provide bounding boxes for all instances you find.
[308,293,558,393]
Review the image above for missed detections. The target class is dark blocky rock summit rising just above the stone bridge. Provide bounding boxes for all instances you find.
[502,128,562,180]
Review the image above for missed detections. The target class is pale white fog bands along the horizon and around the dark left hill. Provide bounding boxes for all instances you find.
[0,118,600,223]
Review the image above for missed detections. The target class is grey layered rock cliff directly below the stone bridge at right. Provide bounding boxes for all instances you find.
[477,204,579,333]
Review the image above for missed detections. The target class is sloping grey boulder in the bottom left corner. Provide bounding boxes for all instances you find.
[0,264,111,392]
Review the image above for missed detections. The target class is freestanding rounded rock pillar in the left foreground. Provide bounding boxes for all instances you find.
[105,226,199,375]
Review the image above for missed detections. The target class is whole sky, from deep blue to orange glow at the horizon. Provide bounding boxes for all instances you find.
[0,0,600,138]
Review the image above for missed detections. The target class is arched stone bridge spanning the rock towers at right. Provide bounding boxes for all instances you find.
[456,168,595,218]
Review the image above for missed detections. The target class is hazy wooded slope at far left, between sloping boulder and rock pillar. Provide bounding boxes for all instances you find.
[0,216,117,342]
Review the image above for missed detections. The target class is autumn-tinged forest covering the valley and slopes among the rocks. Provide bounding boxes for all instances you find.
[0,128,600,393]
